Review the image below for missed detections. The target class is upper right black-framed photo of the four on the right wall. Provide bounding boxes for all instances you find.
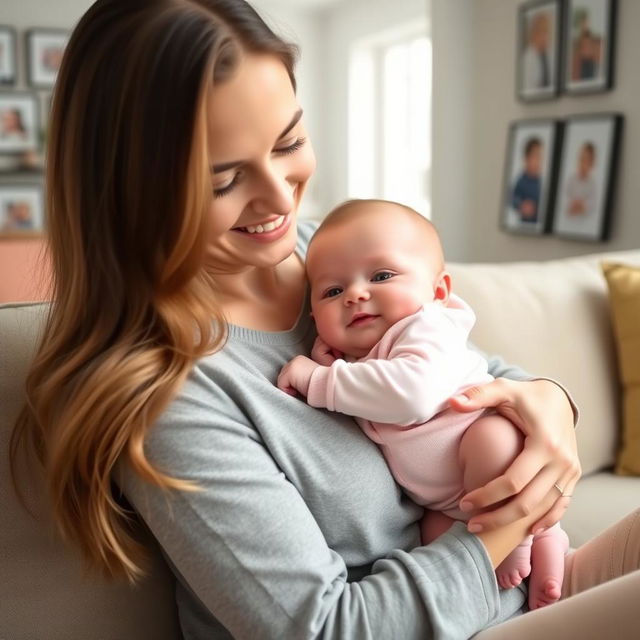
[563,0,617,94]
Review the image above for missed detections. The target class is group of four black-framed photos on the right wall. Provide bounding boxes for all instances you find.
[500,0,624,242]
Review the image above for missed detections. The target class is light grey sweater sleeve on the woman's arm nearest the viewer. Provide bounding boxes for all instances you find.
[118,392,523,640]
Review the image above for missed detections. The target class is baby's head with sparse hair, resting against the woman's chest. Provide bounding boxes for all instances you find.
[307,200,451,358]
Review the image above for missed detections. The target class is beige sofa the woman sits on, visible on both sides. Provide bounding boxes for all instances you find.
[0,250,640,640]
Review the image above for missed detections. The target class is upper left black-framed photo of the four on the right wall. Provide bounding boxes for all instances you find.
[516,0,563,102]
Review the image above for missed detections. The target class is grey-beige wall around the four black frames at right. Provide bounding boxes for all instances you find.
[433,0,640,261]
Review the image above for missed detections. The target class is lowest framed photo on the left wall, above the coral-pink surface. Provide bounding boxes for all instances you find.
[0,184,44,238]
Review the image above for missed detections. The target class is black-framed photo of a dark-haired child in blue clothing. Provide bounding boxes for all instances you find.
[500,119,562,235]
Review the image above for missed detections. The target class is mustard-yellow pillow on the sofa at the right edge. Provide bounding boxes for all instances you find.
[602,262,640,476]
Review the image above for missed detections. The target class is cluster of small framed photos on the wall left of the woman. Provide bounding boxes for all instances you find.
[0,25,69,240]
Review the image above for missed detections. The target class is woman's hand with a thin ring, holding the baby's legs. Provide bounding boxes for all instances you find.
[450,378,581,533]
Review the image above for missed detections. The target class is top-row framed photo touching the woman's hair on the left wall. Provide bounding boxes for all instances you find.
[25,28,70,89]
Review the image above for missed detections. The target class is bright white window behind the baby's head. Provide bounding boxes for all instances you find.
[348,25,431,217]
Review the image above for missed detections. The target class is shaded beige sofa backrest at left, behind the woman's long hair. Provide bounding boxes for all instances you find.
[0,304,182,640]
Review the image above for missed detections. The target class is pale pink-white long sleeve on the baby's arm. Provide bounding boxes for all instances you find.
[307,307,488,426]
